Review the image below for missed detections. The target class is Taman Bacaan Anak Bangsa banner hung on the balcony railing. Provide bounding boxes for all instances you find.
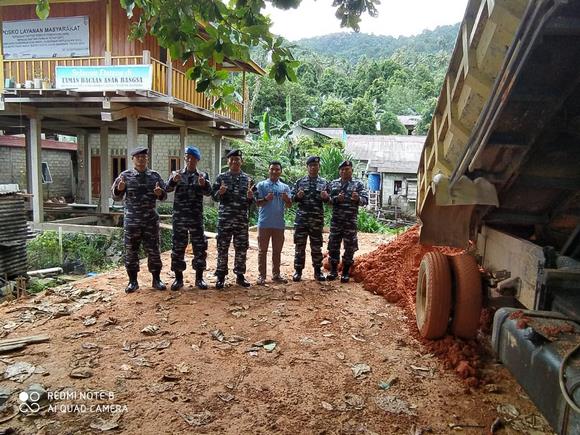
[55,65,153,91]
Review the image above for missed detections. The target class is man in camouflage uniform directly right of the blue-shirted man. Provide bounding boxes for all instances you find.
[292,156,329,282]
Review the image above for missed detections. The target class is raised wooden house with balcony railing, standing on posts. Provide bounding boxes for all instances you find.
[0,0,265,223]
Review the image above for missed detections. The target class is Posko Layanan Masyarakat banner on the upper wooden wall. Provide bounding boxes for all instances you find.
[2,17,90,59]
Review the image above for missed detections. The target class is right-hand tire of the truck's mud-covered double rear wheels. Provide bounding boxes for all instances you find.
[450,254,482,338]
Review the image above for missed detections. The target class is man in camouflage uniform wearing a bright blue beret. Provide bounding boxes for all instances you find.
[167,146,211,290]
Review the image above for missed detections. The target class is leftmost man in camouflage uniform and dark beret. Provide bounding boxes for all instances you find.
[111,147,167,293]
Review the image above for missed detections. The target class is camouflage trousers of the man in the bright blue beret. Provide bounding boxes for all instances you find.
[171,221,207,272]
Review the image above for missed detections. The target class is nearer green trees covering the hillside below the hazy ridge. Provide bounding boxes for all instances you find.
[250,26,456,134]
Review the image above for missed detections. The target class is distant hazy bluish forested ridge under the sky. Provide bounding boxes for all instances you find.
[294,23,459,63]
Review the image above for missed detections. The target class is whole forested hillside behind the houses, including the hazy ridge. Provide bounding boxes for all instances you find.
[247,25,459,137]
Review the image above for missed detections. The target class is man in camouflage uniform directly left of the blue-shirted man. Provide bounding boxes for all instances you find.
[212,150,254,289]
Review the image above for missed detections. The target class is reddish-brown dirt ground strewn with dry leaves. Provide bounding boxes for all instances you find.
[0,232,550,435]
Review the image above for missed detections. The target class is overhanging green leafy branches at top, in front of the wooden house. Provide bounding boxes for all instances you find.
[36,0,378,108]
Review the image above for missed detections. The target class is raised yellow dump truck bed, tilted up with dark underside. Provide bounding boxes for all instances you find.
[417,0,580,258]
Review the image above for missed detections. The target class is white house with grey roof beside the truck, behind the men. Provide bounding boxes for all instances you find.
[346,134,426,213]
